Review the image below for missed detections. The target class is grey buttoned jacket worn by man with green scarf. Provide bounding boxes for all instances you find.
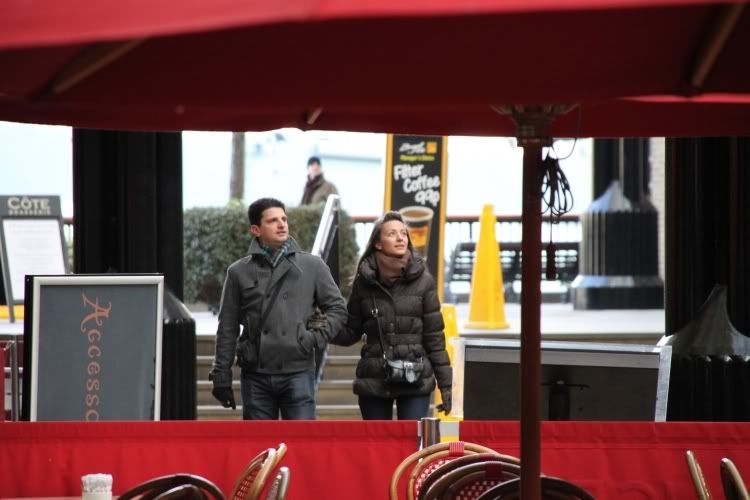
[210,237,346,387]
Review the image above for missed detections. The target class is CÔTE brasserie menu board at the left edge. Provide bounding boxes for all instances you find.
[0,195,68,321]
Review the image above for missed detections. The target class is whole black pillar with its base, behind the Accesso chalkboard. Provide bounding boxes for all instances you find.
[73,129,196,419]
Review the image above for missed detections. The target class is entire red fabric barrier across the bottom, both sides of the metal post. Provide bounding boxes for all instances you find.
[0,421,750,500]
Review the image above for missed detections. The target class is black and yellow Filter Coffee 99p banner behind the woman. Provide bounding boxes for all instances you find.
[384,134,448,298]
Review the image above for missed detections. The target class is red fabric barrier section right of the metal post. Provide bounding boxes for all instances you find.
[461,422,750,500]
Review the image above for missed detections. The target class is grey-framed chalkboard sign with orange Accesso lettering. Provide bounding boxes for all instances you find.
[22,274,164,421]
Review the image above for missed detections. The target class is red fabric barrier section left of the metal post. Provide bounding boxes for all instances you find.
[0,421,416,499]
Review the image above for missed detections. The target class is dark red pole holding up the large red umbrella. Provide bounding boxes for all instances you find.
[519,139,542,499]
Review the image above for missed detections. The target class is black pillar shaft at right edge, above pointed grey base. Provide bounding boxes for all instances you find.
[665,137,750,335]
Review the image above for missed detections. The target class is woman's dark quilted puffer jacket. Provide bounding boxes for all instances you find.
[332,255,452,398]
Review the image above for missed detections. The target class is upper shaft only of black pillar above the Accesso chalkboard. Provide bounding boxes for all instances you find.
[73,129,183,299]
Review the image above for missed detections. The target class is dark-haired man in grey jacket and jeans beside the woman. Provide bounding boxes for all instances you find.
[209,198,346,420]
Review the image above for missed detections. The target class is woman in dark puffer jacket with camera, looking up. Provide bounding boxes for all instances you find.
[331,212,453,420]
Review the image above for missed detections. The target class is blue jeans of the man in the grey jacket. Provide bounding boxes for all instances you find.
[240,368,315,420]
